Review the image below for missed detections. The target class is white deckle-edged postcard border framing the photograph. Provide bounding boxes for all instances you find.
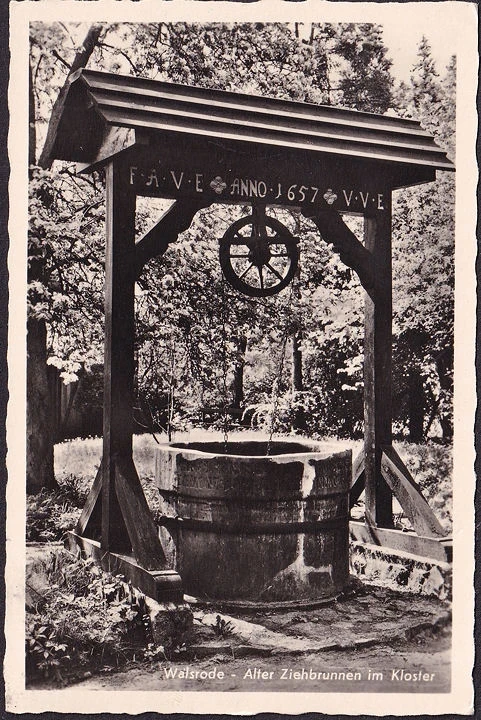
[4,0,478,715]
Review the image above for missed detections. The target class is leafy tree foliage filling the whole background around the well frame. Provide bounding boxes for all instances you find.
[29,23,455,448]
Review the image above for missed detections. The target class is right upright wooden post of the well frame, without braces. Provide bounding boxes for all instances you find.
[364,205,393,528]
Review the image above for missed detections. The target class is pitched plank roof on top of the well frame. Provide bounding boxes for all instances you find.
[53,70,454,170]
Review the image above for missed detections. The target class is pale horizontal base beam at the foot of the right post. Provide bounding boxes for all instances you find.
[349,520,453,562]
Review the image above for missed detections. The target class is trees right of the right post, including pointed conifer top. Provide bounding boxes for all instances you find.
[393,43,456,440]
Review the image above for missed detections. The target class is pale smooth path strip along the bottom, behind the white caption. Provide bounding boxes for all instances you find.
[52,633,451,693]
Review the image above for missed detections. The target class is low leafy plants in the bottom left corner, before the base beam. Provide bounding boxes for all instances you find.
[26,552,152,682]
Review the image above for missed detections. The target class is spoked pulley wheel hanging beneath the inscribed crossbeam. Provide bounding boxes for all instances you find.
[219,208,299,297]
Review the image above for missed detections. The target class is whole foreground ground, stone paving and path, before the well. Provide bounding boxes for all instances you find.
[30,586,451,693]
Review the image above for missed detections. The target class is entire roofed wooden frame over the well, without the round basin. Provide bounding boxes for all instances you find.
[51,70,453,600]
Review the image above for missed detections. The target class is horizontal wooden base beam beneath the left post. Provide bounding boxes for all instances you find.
[65,532,183,602]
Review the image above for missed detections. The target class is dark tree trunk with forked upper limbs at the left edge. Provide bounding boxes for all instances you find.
[27,25,102,494]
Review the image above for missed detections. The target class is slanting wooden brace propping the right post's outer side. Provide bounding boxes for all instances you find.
[381,446,446,537]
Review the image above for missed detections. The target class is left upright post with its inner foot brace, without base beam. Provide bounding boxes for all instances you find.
[100,159,174,580]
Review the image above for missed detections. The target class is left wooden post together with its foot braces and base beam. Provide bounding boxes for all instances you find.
[66,159,183,602]
